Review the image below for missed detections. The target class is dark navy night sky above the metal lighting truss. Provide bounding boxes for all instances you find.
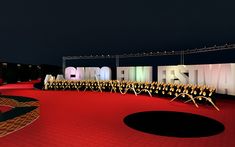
[0,0,235,65]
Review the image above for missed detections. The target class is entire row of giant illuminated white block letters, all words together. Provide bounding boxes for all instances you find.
[60,63,235,95]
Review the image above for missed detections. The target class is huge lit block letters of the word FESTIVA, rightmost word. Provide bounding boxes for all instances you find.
[158,63,235,95]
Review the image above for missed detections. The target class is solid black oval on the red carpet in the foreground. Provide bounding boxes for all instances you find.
[124,111,224,137]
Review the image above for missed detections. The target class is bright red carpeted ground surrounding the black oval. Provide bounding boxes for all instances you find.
[0,83,235,147]
